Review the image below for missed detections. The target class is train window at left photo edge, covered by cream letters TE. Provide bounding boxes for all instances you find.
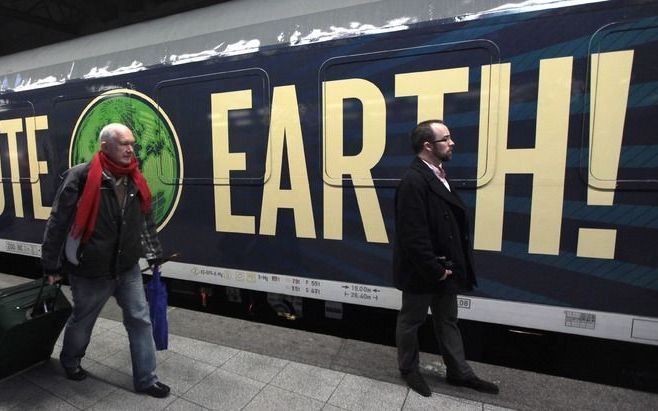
[0,99,39,183]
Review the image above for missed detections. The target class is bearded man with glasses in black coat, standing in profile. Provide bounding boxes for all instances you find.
[393,120,498,397]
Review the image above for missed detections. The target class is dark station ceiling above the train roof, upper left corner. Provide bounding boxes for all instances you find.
[0,0,229,56]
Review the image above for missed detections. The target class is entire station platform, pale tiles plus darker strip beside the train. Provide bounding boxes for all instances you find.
[0,274,658,411]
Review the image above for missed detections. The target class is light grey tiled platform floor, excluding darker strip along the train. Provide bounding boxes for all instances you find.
[0,318,504,411]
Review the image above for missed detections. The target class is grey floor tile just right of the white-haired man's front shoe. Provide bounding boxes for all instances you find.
[156,353,217,395]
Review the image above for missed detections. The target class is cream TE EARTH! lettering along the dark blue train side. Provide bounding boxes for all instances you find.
[0,50,633,264]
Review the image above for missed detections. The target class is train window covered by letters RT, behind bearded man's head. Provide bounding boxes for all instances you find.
[319,40,499,187]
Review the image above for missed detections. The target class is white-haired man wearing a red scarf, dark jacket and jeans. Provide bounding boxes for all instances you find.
[41,124,170,398]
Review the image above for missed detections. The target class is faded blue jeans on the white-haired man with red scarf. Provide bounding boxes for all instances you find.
[59,264,158,390]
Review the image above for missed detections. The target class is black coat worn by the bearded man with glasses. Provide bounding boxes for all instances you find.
[393,157,477,294]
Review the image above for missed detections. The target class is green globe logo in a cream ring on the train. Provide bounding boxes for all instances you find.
[69,89,183,231]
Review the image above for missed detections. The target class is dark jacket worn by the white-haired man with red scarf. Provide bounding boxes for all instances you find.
[41,163,162,277]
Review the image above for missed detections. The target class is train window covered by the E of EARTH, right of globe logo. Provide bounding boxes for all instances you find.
[154,68,270,185]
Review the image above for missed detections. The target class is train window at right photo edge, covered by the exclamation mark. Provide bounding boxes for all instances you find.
[581,22,658,191]
